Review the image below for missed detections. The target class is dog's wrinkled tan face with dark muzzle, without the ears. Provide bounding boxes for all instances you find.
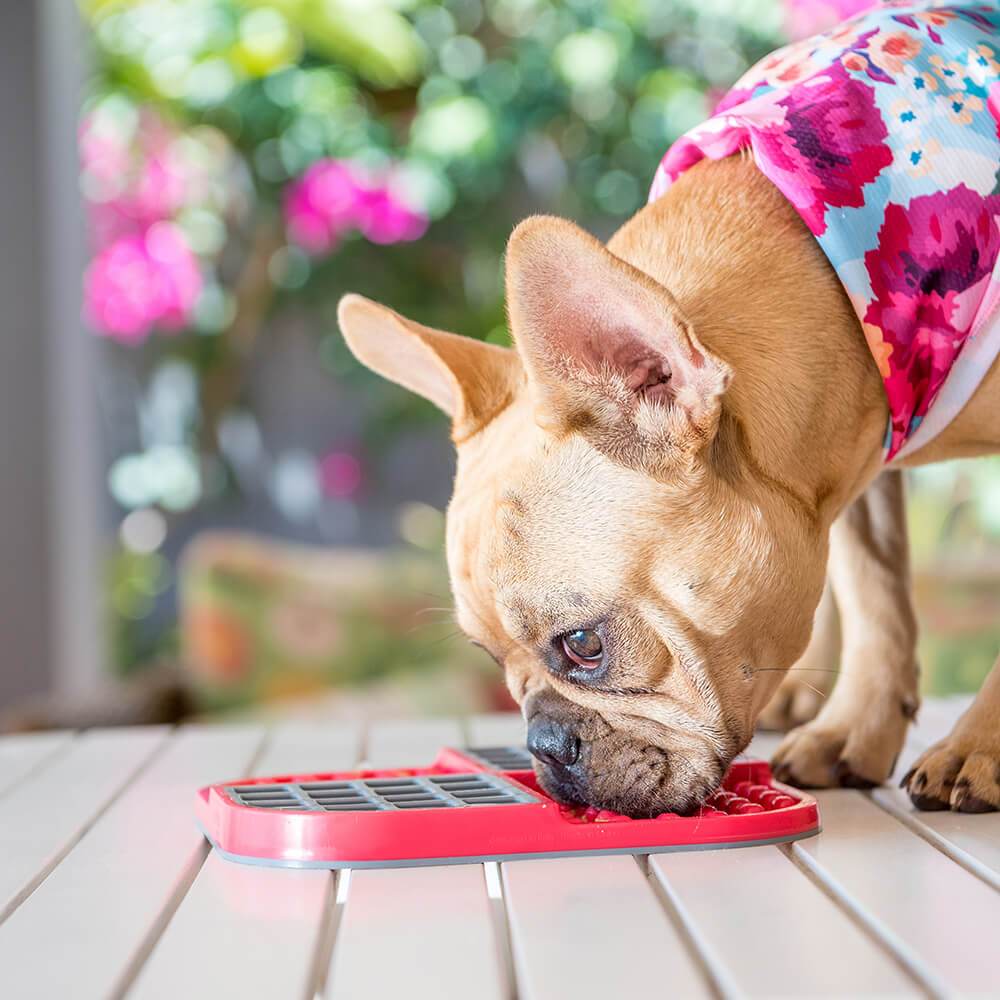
[448,404,820,815]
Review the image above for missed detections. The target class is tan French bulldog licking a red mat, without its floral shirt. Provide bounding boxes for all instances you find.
[340,157,1000,815]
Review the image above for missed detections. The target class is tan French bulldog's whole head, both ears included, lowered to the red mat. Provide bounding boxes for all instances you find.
[340,218,826,815]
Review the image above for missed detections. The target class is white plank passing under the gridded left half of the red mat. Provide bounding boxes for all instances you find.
[129,723,361,1000]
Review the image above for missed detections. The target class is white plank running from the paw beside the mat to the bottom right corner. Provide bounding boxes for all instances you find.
[792,790,1000,994]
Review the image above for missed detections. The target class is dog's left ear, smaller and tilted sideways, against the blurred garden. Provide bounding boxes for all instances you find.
[337,295,524,443]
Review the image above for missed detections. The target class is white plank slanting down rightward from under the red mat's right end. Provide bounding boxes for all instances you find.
[649,847,923,997]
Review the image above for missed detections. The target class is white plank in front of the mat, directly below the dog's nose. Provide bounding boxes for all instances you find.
[504,857,711,1000]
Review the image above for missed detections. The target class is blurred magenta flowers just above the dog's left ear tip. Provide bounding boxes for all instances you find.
[285,160,427,254]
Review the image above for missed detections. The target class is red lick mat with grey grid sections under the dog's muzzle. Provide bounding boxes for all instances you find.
[196,747,819,868]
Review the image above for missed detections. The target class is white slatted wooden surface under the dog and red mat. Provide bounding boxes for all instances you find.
[0,701,1000,1000]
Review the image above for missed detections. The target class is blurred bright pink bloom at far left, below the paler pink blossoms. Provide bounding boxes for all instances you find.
[84,222,202,344]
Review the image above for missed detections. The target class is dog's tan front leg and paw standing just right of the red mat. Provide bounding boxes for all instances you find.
[774,471,919,788]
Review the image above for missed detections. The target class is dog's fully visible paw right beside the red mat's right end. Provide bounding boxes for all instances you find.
[771,713,909,788]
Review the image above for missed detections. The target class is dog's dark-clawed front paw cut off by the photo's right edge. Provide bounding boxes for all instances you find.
[900,732,1000,813]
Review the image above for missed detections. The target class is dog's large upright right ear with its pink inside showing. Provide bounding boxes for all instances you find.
[507,216,732,468]
